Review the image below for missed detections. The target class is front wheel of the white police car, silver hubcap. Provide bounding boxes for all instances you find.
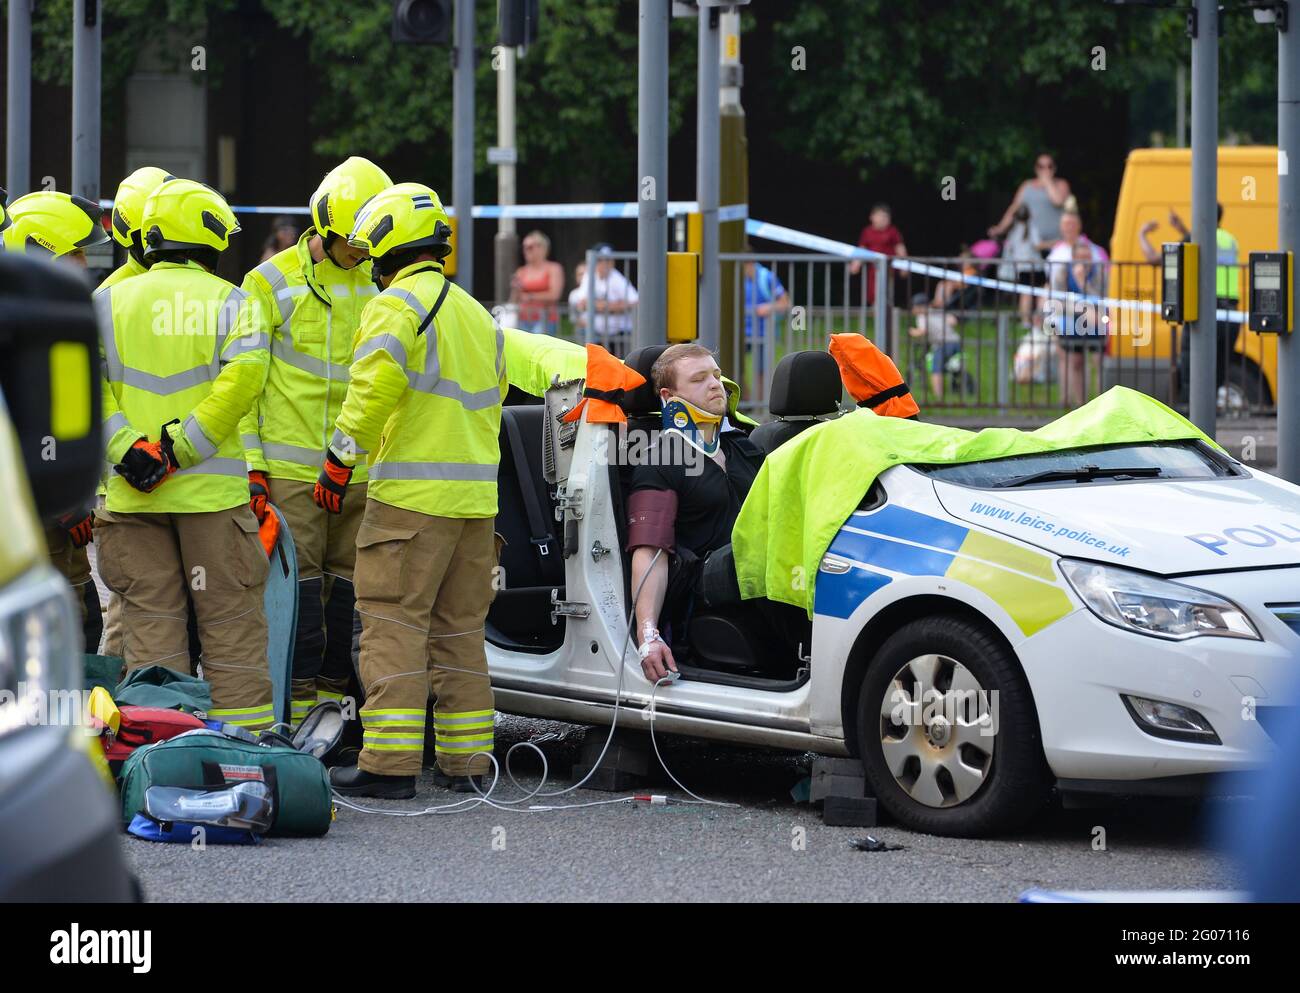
[858,616,1050,837]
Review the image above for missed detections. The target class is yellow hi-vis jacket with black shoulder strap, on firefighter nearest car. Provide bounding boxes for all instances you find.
[330,261,508,517]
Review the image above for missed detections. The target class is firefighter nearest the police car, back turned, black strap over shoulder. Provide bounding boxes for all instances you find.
[315,183,507,798]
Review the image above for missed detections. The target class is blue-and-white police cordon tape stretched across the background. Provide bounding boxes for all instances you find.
[99,200,1247,324]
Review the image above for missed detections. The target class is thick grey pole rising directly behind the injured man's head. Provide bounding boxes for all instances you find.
[633,0,668,347]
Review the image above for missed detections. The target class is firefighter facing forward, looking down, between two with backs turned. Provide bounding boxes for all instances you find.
[239,156,393,724]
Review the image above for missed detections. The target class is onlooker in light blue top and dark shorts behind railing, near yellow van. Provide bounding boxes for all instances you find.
[1045,207,1106,408]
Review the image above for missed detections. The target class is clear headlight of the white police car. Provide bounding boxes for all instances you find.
[1061,559,1262,641]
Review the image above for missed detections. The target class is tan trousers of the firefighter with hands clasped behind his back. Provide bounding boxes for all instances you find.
[95,504,274,729]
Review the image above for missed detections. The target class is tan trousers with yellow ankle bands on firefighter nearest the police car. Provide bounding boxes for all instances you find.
[350,494,497,776]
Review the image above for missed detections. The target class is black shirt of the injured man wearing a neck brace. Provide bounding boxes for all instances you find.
[632,430,763,559]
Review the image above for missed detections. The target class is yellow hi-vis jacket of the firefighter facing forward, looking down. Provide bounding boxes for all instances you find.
[239,227,378,482]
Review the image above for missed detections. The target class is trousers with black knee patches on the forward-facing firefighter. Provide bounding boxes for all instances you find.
[268,477,365,724]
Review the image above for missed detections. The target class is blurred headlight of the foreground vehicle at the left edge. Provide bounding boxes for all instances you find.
[0,565,82,736]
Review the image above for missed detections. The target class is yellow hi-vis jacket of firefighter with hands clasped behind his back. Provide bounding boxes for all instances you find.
[95,263,269,513]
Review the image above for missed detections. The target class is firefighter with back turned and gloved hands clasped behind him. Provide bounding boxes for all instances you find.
[95,179,274,730]
